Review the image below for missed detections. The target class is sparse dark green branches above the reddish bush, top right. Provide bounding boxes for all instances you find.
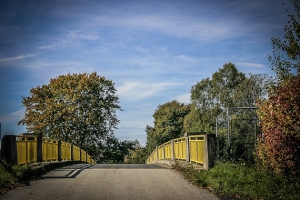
[269,0,300,80]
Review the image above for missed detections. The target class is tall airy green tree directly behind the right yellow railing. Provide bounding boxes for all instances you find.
[184,63,246,132]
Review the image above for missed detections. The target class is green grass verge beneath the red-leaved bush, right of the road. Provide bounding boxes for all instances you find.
[176,162,300,199]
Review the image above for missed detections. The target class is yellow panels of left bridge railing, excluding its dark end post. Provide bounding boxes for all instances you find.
[16,136,96,165]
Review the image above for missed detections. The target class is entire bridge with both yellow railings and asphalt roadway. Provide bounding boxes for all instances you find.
[1,134,222,200]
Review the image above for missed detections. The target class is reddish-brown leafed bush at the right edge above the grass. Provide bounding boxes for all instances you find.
[257,74,300,177]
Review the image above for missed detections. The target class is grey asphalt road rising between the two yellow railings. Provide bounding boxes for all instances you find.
[1,164,224,200]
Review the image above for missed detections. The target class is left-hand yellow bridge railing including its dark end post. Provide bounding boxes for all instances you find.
[1,135,96,165]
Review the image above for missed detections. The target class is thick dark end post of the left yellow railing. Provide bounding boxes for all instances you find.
[1,135,18,165]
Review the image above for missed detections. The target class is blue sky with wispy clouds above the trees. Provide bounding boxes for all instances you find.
[0,0,288,145]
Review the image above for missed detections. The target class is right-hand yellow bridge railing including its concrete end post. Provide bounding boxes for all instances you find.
[146,134,218,169]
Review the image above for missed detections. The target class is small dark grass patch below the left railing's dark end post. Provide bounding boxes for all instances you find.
[0,161,30,196]
